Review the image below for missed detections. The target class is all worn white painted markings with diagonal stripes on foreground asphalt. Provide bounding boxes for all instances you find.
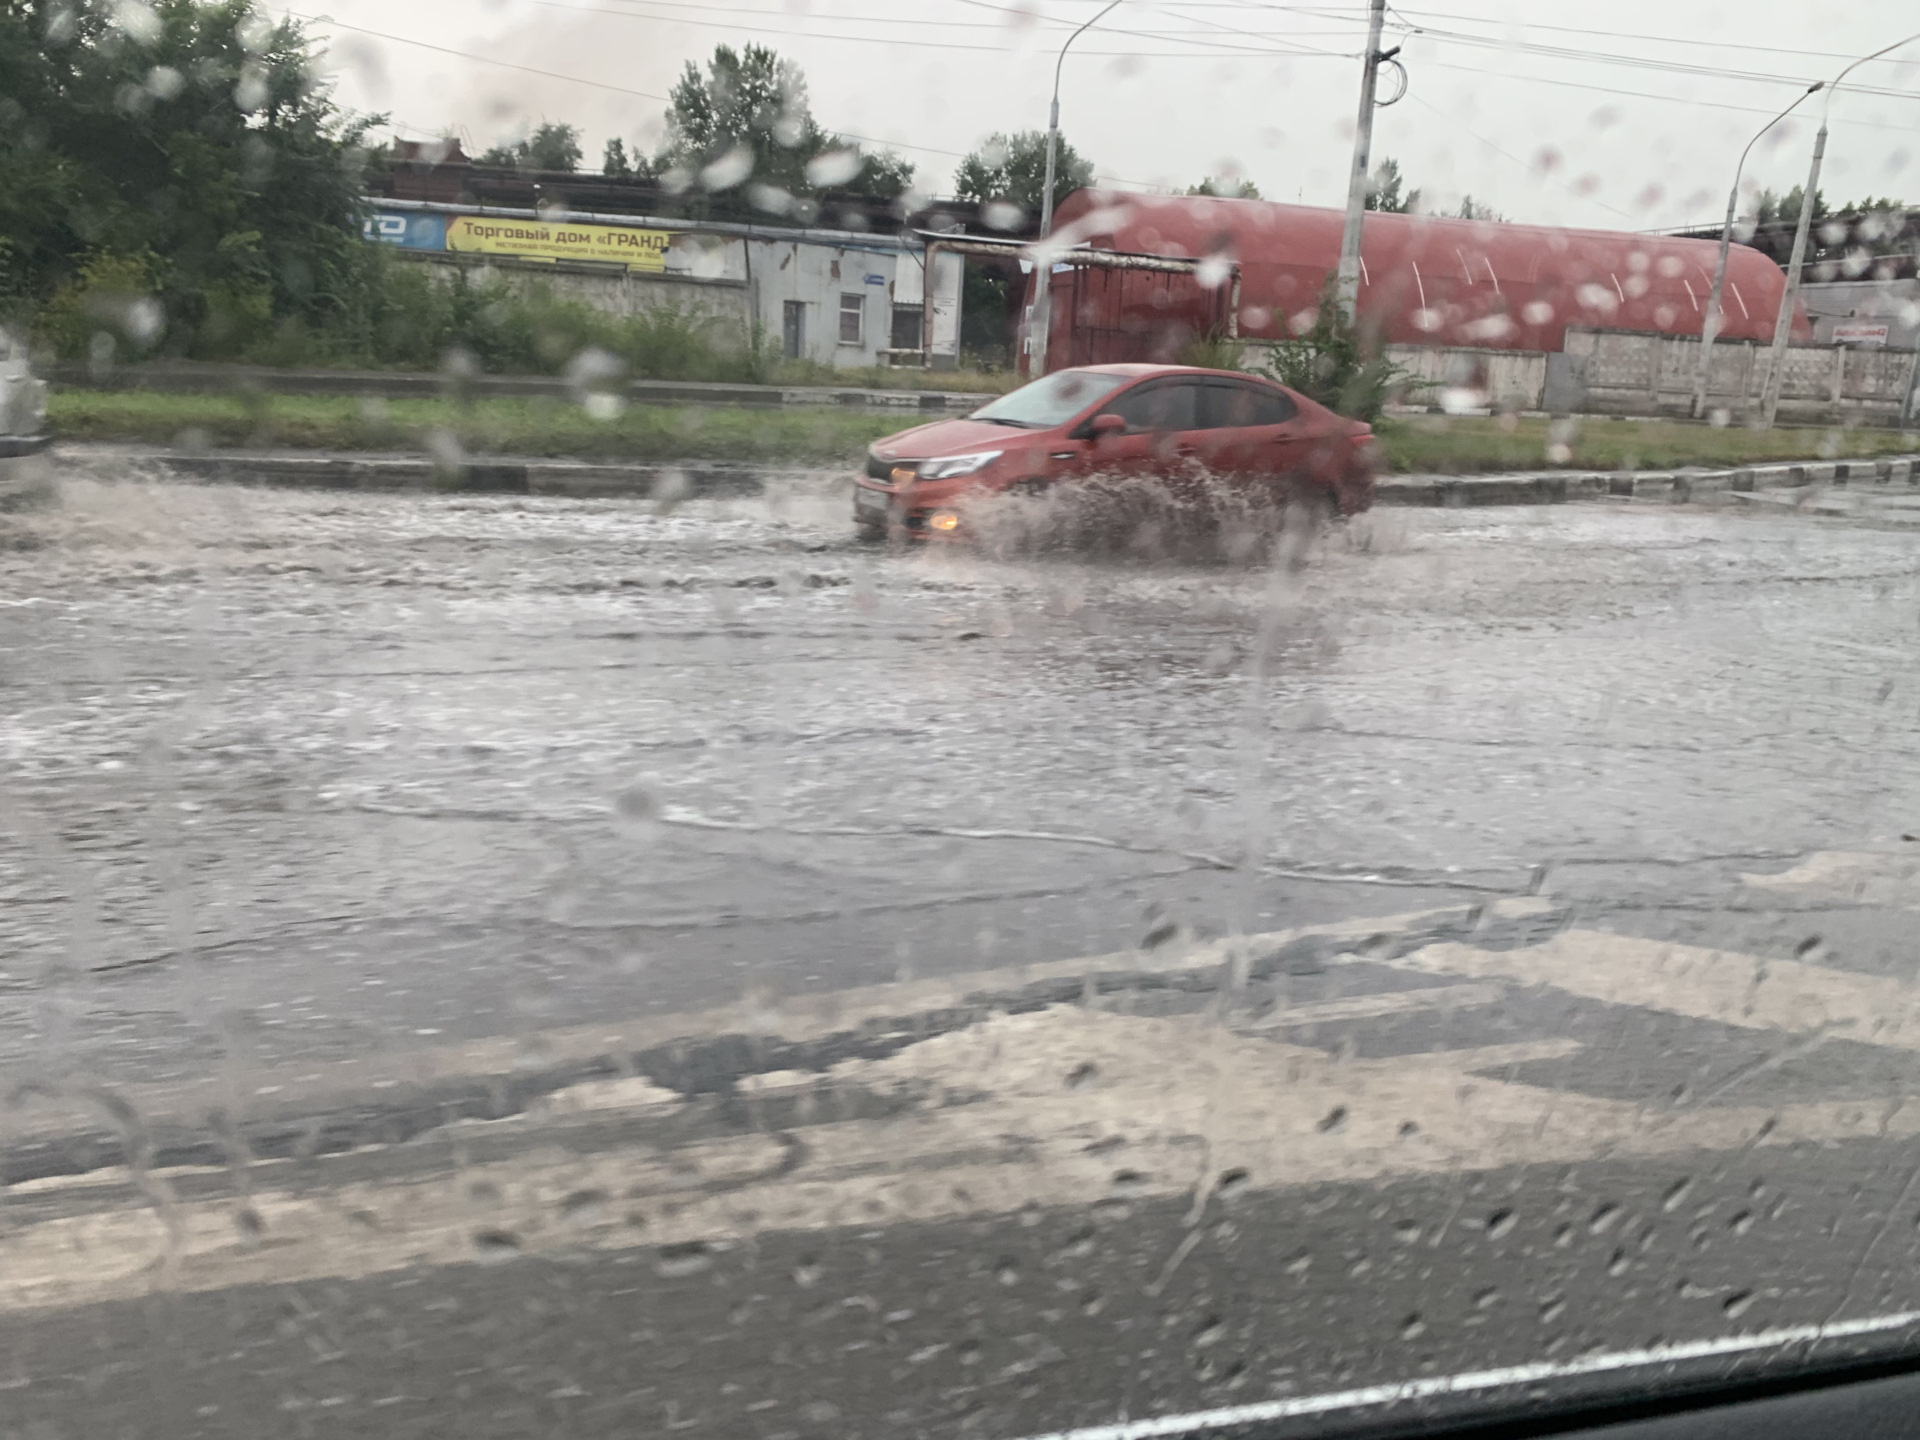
[0,902,1920,1309]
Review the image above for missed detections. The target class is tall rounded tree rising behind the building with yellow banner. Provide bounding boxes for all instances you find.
[657,44,914,200]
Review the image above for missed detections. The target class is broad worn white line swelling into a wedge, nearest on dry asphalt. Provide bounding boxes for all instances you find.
[0,1004,1920,1313]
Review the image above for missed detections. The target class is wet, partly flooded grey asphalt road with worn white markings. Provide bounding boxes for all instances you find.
[0,474,1920,1440]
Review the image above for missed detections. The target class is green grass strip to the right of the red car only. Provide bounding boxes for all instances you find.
[1373,415,1920,474]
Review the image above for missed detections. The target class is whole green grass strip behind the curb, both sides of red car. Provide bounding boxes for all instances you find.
[48,390,1920,474]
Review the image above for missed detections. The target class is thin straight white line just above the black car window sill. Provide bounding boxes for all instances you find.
[998,1309,1920,1440]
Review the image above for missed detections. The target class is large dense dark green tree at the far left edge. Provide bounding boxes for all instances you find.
[0,0,378,355]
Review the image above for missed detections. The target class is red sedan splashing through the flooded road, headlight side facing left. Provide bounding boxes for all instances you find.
[852,365,1377,540]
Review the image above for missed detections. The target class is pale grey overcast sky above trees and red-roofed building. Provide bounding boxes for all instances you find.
[288,0,1920,228]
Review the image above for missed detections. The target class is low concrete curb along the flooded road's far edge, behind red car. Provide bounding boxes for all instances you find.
[45,445,1920,509]
